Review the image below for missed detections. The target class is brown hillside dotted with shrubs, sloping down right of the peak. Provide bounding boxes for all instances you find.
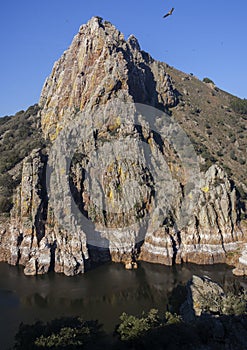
[163,66,247,199]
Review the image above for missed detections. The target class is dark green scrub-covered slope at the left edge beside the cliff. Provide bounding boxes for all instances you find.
[0,104,44,213]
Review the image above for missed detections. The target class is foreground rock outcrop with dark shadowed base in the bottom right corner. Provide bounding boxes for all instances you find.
[180,276,247,349]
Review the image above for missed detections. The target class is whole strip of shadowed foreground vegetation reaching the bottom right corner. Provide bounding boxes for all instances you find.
[13,302,247,350]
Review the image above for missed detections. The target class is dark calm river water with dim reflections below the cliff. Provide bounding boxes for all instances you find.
[0,263,243,349]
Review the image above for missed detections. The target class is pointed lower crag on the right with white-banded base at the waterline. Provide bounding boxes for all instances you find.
[141,165,244,264]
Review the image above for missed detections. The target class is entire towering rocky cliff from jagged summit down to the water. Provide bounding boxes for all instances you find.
[0,18,246,275]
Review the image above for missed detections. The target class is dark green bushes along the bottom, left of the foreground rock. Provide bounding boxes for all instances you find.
[14,309,182,350]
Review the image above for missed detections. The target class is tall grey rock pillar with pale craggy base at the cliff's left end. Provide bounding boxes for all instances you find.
[0,150,87,275]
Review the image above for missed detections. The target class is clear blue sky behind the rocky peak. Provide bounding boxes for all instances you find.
[0,0,247,116]
